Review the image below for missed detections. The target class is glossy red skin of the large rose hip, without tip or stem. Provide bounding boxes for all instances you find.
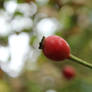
[43,35,70,61]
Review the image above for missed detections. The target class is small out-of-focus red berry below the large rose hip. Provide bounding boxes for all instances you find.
[63,66,75,80]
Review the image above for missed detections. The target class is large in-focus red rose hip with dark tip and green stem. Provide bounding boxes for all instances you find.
[39,35,92,69]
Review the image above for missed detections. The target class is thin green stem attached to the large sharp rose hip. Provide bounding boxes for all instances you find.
[69,54,92,69]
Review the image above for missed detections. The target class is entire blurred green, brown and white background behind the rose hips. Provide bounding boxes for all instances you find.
[0,0,92,92]
